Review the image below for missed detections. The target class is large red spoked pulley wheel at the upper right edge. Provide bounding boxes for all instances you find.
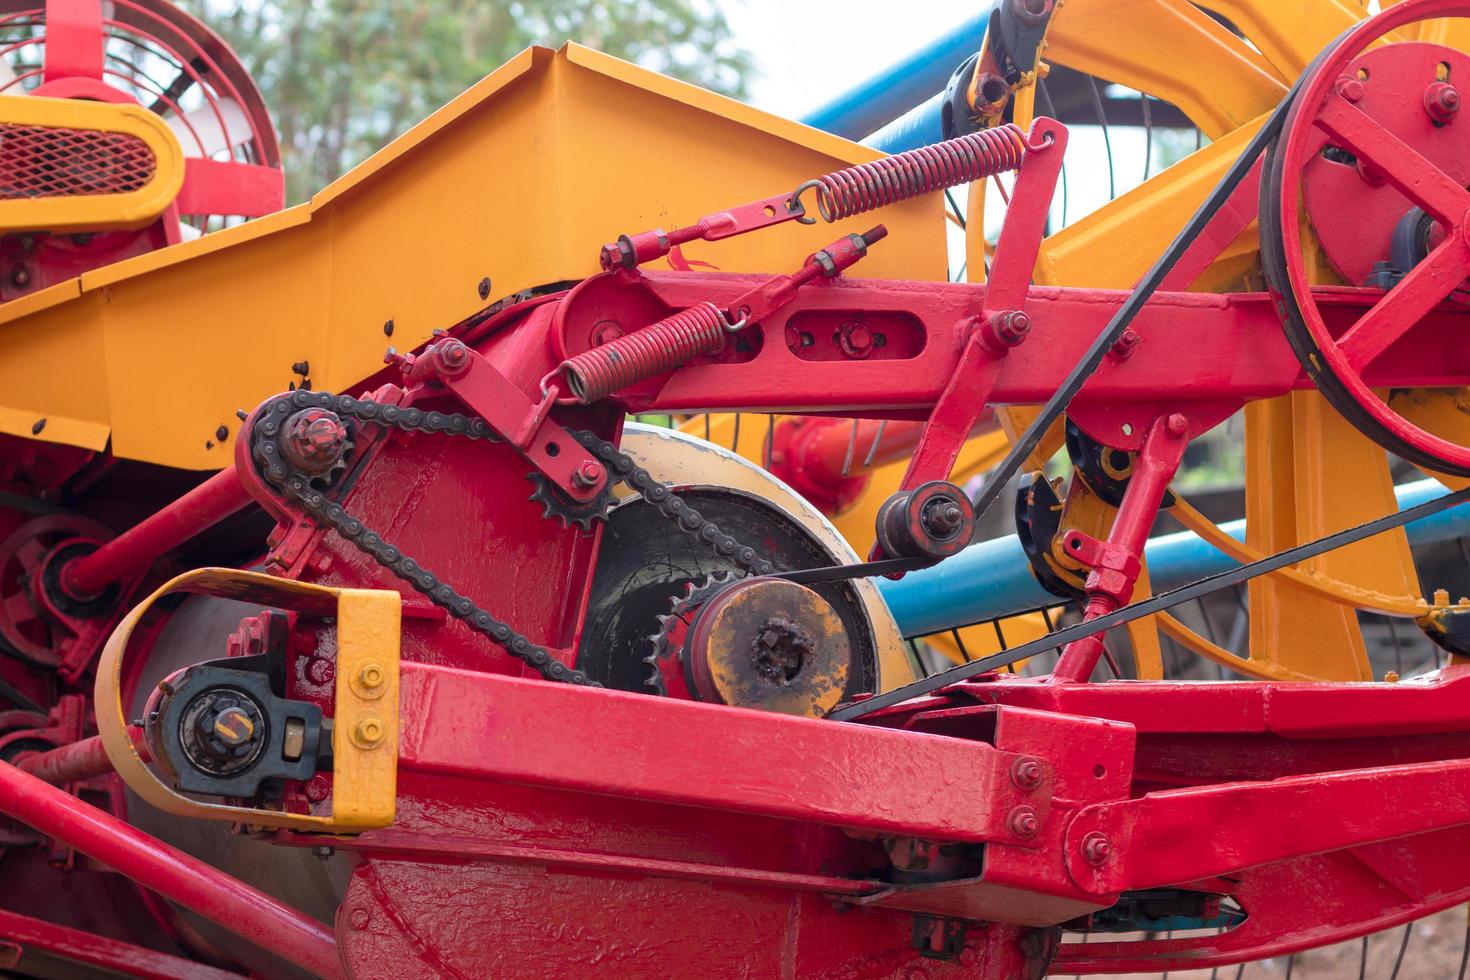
[1261,0,1470,476]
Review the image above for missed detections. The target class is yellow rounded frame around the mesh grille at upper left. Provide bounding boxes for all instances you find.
[0,96,184,234]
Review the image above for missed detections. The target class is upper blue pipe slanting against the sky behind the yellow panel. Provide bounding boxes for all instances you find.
[801,4,992,140]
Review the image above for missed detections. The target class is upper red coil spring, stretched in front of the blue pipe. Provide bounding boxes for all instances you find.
[798,123,1026,222]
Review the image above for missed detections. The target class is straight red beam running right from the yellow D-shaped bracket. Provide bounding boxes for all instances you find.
[398,663,1045,840]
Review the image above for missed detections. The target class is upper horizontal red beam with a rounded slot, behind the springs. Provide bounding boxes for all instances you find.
[555,272,1470,414]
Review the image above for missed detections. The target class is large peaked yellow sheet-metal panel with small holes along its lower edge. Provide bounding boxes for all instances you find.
[0,46,945,469]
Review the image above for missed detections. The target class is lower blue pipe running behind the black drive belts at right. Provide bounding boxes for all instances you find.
[876,480,1470,636]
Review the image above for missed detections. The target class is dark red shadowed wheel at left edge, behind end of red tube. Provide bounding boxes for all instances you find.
[0,514,112,667]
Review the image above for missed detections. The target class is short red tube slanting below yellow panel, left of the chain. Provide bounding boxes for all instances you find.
[62,466,254,597]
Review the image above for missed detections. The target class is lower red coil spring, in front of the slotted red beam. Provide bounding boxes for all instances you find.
[557,303,729,404]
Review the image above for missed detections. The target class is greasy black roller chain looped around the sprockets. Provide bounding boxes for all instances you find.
[251,391,773,688]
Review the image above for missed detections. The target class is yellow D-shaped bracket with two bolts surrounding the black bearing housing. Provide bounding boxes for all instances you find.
[96,569,401,833]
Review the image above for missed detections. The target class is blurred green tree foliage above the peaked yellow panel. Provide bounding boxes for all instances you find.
[185,0,751,203]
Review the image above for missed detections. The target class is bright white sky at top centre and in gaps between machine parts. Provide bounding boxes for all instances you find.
[717,0,1158,270]
